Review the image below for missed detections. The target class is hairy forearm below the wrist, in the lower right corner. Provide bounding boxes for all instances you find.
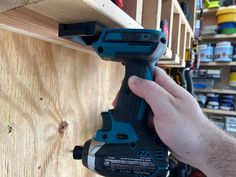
[200,121,236,177]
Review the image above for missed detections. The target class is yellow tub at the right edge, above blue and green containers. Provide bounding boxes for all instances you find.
[216,6,236,24]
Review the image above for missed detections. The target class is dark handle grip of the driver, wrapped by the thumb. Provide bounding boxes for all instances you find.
[113,60,155,123]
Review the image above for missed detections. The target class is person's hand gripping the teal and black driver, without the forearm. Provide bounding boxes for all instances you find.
[113,67,215,170]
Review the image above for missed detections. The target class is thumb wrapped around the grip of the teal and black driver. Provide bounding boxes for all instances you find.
[128,76,172,112]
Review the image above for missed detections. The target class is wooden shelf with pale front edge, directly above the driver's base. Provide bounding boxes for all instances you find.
[0,0,143,53]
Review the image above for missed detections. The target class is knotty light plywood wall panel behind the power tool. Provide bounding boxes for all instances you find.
[0,31,123,177]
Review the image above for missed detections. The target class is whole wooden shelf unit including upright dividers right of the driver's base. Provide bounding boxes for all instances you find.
[0,0,195,67]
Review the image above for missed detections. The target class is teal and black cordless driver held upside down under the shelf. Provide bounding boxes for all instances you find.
[59,22,169,177]
